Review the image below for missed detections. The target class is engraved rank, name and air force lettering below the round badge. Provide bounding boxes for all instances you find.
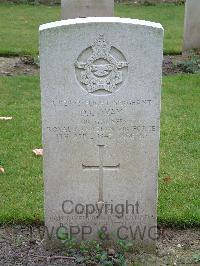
[46,99,155,143]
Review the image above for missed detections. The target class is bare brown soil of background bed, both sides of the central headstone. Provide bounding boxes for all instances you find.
[0,55,194,76]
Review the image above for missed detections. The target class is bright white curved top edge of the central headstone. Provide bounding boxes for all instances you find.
[39,17,163,31]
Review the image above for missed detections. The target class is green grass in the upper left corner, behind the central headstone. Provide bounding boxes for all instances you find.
[0,4,59,56]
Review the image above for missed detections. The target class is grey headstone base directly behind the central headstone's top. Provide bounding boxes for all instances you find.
[61,0,114,19]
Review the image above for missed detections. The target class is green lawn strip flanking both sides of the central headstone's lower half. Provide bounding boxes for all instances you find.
[0,75,200,226]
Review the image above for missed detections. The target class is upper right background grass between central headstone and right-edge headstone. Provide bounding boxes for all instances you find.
[115,4,184,54]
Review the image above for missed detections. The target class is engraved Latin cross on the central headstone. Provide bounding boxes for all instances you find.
[82,145,120,203]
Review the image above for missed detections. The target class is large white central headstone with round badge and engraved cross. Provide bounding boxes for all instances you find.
[40,18,163,250]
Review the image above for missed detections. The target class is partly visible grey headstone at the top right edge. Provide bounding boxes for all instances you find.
[183,0,200,51]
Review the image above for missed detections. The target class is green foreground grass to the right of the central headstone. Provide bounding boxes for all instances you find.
[158,74,200,225]
